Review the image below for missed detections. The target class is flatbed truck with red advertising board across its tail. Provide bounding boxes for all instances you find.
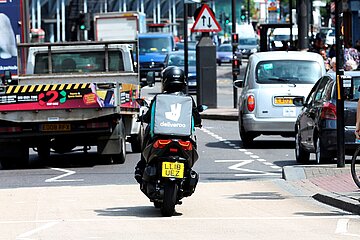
[0,40,142,168]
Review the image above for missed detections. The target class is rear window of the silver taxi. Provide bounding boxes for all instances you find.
[256,60,322,84]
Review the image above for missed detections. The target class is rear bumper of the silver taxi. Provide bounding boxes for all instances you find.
[242,114,296,133]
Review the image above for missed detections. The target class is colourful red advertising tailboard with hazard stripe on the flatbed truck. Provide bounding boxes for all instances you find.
[0,83,139,112]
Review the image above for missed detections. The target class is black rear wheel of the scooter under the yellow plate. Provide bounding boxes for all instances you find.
[160,181,178,217]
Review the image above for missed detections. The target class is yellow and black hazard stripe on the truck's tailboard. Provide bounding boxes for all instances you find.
[6,83,91,94]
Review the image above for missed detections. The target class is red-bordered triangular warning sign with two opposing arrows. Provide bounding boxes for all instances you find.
[191,4,221,32]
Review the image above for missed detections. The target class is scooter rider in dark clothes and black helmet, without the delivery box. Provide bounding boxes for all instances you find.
[135,66,201,183]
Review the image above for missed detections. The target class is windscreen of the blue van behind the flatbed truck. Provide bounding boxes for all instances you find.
[139,37,172,53]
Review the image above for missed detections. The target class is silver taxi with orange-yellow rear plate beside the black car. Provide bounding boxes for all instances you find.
[234,51,326,146]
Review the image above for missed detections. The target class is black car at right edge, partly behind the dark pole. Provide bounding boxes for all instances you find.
[295,71,360,163]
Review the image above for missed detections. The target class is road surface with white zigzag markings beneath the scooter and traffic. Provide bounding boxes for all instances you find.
[0,62,360,240]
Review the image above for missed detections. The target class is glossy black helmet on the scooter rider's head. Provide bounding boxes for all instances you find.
[161,66,186,92]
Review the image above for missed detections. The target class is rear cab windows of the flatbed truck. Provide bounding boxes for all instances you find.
[34,51,124,74]
